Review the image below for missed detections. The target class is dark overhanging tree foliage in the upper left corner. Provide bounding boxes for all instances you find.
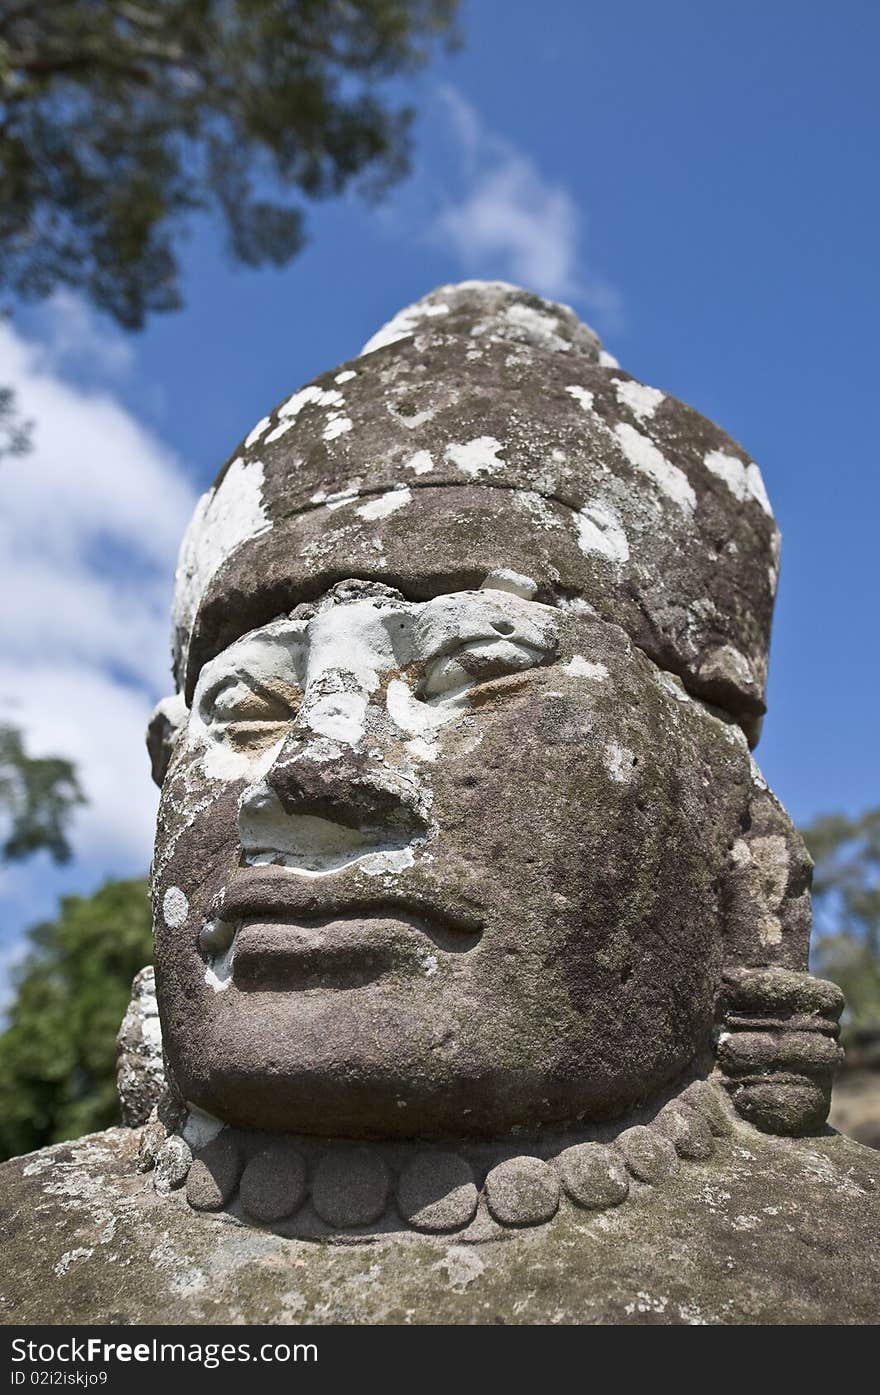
[0,0,457,328]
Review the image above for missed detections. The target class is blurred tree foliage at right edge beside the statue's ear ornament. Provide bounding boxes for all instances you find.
[803,808,880,1030]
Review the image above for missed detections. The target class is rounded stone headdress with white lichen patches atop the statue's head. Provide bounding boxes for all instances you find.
[176,283,778,724]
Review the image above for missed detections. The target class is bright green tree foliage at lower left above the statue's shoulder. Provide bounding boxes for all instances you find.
[0,879,152,1158]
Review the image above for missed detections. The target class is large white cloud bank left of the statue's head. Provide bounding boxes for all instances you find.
[0,309,195,864]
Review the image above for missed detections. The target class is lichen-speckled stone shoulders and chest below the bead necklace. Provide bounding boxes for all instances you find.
[0,1124,880,1325]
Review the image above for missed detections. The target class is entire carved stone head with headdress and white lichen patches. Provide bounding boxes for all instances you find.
[151,283,837,1138]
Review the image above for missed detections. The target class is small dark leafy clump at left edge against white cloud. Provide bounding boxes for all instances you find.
[0,725,85,862]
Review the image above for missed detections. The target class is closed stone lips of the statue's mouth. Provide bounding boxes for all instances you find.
[199,866,484,992]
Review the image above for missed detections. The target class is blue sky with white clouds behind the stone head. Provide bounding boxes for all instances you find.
[0,0,880,987]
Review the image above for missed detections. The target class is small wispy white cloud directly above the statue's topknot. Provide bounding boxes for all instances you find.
[431,86,618,314]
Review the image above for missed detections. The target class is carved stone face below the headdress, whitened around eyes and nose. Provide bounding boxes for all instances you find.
[153,571,749,1137]
